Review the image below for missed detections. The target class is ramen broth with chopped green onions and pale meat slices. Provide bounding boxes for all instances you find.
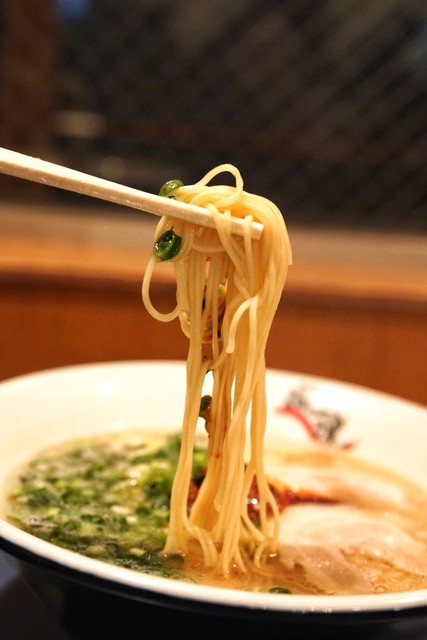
[7,431,427,595]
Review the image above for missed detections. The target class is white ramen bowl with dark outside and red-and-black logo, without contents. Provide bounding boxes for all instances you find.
[0,361,427,639]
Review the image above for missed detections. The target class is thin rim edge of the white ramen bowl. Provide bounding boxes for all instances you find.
[0,360,427,616]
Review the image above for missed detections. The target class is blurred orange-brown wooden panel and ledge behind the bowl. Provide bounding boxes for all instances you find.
[0,206,427,405]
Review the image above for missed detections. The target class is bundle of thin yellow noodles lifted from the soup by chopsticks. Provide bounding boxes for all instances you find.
[142,164,291,574]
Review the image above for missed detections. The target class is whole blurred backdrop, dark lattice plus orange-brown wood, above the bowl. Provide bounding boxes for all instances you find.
[0,0,427,405]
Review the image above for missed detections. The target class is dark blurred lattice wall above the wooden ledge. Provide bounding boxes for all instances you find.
[0,0,427,232]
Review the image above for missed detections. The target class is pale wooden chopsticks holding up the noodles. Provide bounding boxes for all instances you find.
[0,147,263,240]
